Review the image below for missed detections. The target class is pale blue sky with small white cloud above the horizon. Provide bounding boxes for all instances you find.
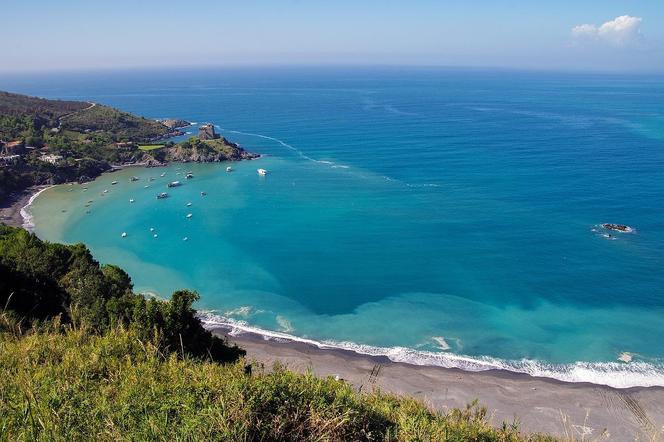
[0,0,664,72]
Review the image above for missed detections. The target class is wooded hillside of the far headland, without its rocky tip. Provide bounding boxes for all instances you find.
[0,92,171,200]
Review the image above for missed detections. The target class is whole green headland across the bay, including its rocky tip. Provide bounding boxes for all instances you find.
[0,92,254,201]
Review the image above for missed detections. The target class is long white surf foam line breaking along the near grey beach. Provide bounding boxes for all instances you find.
[199,312,664,388]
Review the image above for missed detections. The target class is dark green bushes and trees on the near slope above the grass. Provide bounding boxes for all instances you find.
[0,225,244,362]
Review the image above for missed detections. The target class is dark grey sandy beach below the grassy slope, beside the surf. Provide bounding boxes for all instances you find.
[211,326,664,441]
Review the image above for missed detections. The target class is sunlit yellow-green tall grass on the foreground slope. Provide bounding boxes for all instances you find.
[0,318,553,441]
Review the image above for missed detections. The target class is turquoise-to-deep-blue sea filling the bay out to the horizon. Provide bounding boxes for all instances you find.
[5,69,664,387]
